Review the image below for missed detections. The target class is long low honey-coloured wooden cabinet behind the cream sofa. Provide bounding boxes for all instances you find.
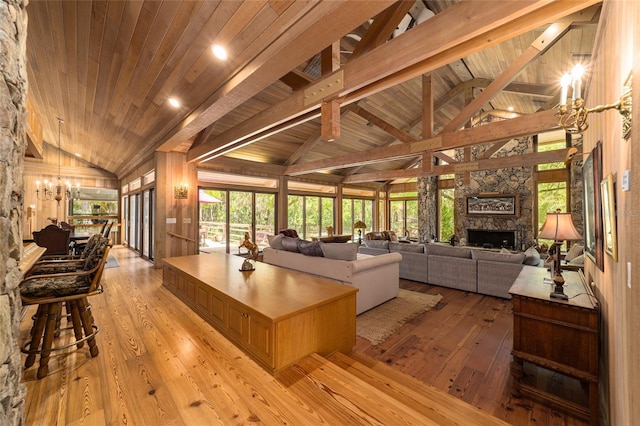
[163,253,358,374]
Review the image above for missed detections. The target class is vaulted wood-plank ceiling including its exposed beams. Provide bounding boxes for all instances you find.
[27,0,599,182]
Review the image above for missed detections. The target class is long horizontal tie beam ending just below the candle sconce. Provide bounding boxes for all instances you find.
[285,110,559,175]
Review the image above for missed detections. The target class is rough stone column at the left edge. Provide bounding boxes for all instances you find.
[0,0,27,425]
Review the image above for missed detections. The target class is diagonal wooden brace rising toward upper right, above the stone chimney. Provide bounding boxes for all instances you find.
[442,22,571,133]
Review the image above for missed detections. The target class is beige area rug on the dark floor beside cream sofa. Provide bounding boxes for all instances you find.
[356,289,442,345]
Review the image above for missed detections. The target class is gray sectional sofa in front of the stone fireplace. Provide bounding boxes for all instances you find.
[358,240,544,299]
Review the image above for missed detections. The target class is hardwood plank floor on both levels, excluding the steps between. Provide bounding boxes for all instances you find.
[21,247,585,425]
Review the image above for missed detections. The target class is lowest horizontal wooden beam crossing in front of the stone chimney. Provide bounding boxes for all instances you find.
[343,148,569,184]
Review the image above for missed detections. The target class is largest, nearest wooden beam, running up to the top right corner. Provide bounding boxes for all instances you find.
[187,0,598,161]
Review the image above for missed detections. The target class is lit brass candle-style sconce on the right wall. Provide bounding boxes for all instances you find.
[558,64,631,139]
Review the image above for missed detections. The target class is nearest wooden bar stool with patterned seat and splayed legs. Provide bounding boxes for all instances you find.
[20,238,109,379]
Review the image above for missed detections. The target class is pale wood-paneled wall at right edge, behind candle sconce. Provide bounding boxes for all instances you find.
[584,1,640,425]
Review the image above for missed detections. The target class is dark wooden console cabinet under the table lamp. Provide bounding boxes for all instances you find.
[509,268,600,425]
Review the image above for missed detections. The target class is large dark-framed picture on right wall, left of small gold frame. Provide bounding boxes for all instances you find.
[582,142,604,271]
